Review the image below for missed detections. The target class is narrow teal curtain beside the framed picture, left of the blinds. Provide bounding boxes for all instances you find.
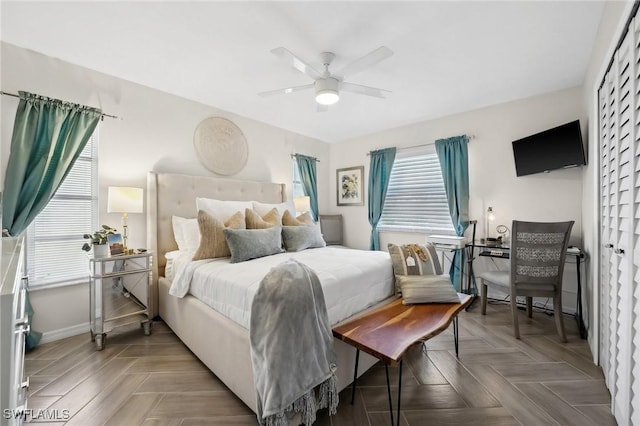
[369,148,396,250]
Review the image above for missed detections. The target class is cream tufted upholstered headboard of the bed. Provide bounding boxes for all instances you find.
[147,172,286,315]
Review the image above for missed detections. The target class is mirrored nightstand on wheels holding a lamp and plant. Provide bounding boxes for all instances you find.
[89,252,153,350]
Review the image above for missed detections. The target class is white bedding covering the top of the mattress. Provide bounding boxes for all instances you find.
[169,247,394,329]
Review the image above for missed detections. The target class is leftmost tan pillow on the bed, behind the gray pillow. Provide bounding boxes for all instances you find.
[193,210,246,260]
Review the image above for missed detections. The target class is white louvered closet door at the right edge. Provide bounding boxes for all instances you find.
[599,11,640,425]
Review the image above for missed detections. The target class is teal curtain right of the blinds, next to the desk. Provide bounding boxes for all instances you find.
[436,136,469,289]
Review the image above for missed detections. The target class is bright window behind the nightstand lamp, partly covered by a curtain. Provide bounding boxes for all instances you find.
[26,129,98,288]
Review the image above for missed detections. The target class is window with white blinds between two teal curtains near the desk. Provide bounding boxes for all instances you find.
[378,145,455,235]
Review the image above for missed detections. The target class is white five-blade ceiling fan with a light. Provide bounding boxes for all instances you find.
[258,46,393,111]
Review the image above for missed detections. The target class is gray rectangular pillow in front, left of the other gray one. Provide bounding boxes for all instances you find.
[224,226,283,263]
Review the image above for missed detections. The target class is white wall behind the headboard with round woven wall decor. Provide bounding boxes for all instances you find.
[1,43,329,337]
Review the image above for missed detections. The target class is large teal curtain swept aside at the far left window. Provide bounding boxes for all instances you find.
[2,92,101,348]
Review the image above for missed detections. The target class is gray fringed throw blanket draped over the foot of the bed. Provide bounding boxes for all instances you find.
[249,260,338,426]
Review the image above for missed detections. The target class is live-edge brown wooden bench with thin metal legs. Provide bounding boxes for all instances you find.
[333,293,473,426]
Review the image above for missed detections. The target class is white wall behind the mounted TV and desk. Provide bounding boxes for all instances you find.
[329,87,586,310]
